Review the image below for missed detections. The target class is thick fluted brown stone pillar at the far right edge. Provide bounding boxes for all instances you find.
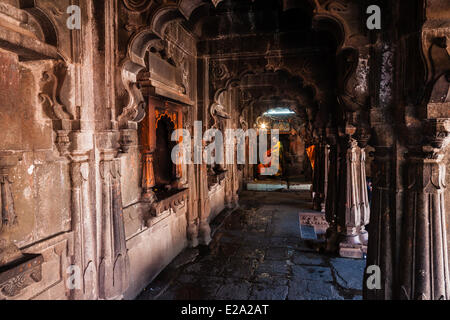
[400,119,450,300]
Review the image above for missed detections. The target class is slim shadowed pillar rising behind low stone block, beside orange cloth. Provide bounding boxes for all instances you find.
[313,135,328,212]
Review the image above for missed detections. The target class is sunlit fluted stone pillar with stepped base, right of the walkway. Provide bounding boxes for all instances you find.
[337,135,362,258]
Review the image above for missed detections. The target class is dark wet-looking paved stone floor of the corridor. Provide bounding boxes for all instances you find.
[138,191,365,300]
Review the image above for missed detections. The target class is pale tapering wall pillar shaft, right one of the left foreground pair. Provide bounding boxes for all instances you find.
[99,150,129,300]
